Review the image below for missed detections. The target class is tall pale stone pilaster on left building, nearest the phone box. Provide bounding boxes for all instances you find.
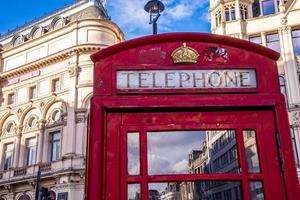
[62,51,80,157]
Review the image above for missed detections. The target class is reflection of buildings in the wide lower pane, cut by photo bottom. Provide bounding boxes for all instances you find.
[149,181,243,200]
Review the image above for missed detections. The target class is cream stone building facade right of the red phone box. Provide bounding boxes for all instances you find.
[209,0,300,177]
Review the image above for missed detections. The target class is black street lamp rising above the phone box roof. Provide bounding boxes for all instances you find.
[144,0,165,34]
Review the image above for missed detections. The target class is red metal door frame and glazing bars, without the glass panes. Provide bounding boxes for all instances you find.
[119,111,285,199]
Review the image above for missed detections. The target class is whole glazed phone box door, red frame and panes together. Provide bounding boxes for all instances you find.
[120,113,284,200]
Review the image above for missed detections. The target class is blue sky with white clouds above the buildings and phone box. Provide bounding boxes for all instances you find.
[0,0,210,39]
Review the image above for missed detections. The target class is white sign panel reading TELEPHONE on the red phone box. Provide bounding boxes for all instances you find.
[117,69,257,90]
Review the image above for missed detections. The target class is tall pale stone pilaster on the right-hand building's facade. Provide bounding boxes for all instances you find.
[279,24,300,105]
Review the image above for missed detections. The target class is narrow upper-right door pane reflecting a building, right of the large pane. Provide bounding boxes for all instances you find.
[243,130,260,173]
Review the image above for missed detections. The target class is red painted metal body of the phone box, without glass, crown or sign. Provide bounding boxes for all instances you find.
[87,33,300,200]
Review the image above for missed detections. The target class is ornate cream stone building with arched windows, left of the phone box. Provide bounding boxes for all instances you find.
[0,0,124,200]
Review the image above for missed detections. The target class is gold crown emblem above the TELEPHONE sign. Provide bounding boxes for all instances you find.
[171,42,199,64]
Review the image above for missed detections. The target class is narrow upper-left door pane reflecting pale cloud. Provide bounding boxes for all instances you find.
[127,133,140,175]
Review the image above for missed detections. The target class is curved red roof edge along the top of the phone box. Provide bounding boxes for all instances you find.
[91,32,280,63]
